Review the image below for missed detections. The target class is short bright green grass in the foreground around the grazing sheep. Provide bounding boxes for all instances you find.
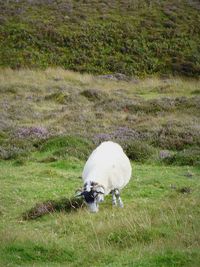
[0,160,200,266]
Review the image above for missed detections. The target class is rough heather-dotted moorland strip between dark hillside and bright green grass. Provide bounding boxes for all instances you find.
[0,69,200,165]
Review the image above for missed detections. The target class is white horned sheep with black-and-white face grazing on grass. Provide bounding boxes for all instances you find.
[77,141,132,212]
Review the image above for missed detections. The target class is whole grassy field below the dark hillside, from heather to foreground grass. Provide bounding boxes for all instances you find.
[0,69,200,267]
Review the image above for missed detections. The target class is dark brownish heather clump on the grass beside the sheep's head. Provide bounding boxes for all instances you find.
[22,197,84,220]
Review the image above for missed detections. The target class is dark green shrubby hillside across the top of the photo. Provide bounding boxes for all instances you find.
[0,0,200,76]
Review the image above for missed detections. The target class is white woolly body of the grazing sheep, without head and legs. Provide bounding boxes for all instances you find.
[82,141,131,194]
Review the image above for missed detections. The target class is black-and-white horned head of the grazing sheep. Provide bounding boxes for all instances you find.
[76,182,105,212]
